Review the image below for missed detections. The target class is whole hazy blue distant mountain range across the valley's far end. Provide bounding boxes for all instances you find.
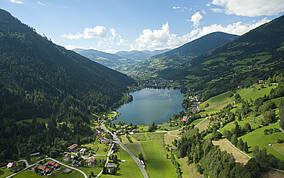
[73,49,168,73]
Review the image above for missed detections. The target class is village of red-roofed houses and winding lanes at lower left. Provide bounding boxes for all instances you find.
[2,112,148,177]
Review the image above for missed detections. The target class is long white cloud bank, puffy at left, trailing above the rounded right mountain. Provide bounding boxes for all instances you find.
[130,18,270,50]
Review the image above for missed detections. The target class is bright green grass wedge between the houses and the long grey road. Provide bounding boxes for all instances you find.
[100,148,143,178]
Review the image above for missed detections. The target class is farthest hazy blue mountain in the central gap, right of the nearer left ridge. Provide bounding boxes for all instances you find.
[115,49,169,62]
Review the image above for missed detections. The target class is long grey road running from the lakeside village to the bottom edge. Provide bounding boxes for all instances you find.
[101,123,148,178]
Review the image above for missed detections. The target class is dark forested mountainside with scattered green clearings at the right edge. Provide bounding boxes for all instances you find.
[157,16,284,99]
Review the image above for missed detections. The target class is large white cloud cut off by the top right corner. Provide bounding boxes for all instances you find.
[211,0,284,17]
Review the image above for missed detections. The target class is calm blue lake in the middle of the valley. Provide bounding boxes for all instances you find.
[115,88,183,125]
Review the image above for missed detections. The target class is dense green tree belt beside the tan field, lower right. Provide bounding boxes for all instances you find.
[177,126,284,178]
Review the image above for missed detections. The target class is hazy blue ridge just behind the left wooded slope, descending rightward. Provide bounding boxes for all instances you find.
[73,49,129,71]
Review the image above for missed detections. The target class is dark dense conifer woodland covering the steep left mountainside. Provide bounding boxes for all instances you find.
[0,10,133,163]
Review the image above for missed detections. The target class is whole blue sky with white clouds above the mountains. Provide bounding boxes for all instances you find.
[0,0,284,53]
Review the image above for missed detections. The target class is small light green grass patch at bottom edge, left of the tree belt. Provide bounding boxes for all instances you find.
[179,158,203,178]
